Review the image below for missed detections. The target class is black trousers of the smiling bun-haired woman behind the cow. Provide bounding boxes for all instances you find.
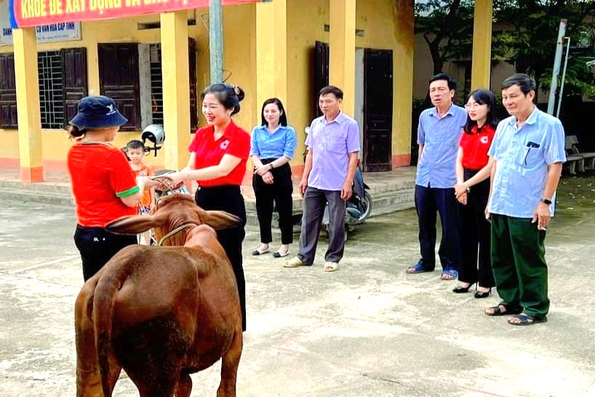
[195,185,246,331]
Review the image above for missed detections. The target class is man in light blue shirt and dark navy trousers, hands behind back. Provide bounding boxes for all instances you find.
[407,73,467,280]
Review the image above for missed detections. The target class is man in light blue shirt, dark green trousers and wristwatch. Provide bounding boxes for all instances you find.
[486,73,566,325]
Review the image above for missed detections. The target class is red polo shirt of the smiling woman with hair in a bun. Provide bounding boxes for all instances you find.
[188,121,250,187]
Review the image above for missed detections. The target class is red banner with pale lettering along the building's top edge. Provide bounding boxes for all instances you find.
[9,0,271,28]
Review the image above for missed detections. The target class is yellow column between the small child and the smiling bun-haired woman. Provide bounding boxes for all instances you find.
[161,11,191,170]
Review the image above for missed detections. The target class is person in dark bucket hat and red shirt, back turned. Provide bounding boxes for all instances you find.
[67,96,151,281]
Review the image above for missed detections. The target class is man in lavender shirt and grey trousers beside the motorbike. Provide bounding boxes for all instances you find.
[283,86,360,272]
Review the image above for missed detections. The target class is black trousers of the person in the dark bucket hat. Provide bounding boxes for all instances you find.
[74,225,137,281]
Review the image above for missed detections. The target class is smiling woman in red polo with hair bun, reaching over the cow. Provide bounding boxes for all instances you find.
[167,84,250,331]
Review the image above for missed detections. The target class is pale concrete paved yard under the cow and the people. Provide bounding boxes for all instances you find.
[0,177,595,397]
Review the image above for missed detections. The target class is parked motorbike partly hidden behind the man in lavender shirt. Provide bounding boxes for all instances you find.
[304,127,372,240]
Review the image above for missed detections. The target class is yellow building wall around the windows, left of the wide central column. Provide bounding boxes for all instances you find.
[0,5,254,171]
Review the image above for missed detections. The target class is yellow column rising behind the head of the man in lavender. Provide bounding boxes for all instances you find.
[328,0,356,117]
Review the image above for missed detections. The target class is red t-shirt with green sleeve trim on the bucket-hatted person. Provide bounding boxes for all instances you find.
[67,143,139,227]
